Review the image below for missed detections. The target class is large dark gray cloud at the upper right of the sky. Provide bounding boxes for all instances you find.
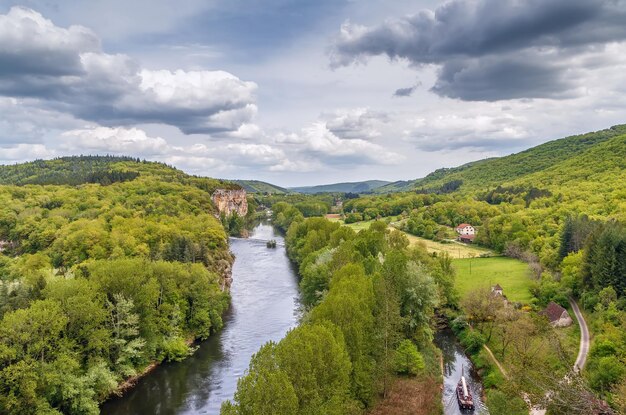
[331,0,626,101]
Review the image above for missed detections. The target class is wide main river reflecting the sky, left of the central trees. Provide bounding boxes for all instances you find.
[101,224,299,415]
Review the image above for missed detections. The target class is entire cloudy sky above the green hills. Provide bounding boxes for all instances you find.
[0,0,626,186]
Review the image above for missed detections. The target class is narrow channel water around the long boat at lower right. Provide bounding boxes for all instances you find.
[435,329,489,415]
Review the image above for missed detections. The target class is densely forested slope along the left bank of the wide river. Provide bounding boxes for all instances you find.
[0,157,234,414]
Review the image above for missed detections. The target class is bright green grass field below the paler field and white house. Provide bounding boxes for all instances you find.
[452,257,532,303]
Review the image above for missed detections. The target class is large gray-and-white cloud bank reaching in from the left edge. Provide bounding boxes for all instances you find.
[0,7,257,134]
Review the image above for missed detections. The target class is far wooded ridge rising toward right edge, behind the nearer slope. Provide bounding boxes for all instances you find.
[375,125,626,193]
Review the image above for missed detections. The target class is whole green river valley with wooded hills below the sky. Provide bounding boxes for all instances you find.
[0,126,626,414]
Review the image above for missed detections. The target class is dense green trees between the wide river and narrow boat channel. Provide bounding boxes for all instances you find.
[222,216,444,414]
